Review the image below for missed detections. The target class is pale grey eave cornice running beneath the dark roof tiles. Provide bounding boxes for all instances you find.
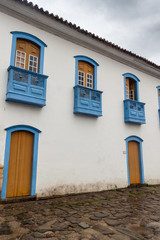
[0,0,160,79]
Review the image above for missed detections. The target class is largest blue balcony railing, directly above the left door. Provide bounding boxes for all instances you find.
[6,66,48,107]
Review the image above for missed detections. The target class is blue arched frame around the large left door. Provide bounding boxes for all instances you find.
[1,125,41,199]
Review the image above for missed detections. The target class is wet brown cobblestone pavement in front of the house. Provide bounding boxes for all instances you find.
[0,186,160,240]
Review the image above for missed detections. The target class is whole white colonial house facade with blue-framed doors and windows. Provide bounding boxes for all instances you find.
[0,0,160,199]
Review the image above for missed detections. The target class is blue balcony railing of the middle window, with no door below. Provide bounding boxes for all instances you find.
[74,85,102,117]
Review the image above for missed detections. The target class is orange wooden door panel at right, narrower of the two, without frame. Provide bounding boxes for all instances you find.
[128,141,141,184]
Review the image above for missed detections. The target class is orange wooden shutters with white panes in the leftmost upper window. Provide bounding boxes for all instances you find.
[15,39,40,72]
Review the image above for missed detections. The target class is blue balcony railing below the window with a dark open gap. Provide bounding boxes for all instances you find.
[124,99,146,124]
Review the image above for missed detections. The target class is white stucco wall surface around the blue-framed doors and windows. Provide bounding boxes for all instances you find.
[0,10,160,196]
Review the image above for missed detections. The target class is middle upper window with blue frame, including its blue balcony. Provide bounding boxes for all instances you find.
[74,55,102,117]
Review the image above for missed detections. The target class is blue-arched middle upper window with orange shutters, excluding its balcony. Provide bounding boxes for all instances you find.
[75,55,99,90]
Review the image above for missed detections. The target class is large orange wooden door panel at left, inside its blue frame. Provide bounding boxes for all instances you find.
[6,131,34,197]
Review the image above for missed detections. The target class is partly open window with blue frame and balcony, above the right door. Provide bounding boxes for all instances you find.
[123,73,146,124]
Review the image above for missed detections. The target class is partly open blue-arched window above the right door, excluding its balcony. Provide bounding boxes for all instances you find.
[123,73,139,101]
